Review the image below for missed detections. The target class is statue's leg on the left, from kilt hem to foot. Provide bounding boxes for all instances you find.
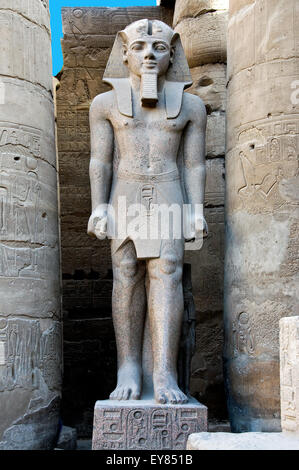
[110,241,146,400]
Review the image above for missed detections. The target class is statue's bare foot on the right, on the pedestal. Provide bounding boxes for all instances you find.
[154,372,188,405]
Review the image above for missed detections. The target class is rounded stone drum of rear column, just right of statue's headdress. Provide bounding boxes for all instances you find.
[175,11,228,68]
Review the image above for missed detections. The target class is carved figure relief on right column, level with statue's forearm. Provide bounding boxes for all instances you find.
[227,115,299,213]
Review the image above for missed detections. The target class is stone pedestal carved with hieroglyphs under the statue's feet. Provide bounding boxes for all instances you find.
[92,399,208,450]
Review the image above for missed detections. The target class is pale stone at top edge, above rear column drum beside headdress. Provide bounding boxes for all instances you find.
[173,0,228,26]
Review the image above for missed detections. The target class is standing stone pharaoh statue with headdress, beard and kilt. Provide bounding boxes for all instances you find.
[88,19,207,404]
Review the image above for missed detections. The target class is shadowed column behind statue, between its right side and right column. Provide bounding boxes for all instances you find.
[174,0,228,419]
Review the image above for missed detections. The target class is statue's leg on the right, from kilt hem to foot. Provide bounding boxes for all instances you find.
[147,240,188,403]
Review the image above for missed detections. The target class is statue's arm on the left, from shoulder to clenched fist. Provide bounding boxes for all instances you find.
[87,93,114,238]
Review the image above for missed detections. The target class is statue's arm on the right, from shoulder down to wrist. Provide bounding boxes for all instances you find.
[183,93,207,237]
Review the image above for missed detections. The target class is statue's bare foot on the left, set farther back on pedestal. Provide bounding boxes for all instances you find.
[109,363,141,400]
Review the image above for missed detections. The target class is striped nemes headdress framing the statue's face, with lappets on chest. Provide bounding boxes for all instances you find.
[103,19,192,119]
